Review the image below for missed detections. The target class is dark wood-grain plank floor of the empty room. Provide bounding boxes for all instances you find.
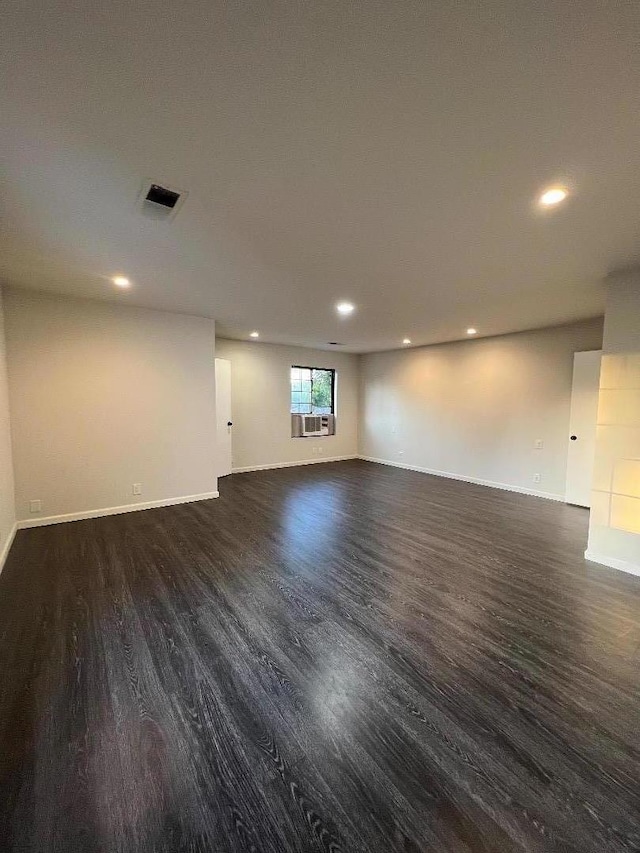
[0,461,640,853]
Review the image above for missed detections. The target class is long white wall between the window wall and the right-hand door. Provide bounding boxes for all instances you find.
[360,320,602,497]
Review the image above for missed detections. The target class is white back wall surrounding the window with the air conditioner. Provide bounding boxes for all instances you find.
[216,338,358,470]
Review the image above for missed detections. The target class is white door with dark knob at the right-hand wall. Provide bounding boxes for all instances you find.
[565,350,602,507]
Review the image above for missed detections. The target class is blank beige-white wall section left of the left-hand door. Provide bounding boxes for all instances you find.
[5,290,217,521]
